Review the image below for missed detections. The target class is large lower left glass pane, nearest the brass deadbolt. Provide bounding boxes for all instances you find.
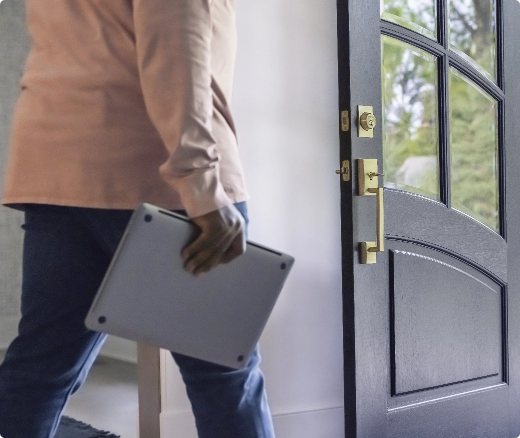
[381,36,439,200]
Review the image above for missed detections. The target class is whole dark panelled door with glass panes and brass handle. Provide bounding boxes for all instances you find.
[338,0,520,438]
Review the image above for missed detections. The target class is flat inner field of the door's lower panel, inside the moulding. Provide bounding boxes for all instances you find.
[389,250,502,395]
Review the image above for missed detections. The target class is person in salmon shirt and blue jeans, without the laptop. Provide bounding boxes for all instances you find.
[0,0,274,438]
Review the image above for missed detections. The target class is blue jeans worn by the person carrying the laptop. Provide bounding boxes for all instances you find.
[0,203,274,438]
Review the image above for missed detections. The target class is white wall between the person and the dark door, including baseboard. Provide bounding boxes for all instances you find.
[161,0,344,438]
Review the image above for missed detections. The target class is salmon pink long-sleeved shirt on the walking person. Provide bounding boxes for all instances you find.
[3,0,247,217]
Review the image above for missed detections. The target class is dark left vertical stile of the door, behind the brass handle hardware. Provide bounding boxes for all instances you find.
[337,0,389,438]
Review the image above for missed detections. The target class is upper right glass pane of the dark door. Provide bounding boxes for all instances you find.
[448,0,497,80]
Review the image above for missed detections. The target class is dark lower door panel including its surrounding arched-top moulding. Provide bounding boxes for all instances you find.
[385,237,508,412]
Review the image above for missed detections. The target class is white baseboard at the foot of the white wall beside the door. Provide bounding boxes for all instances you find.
[161,408,345,438]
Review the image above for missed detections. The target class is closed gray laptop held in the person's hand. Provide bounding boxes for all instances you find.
[85,204,294,368]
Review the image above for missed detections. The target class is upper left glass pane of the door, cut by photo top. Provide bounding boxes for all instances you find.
[380,0,437,38]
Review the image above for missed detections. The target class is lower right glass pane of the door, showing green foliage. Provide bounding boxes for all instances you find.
[449,67,499,232]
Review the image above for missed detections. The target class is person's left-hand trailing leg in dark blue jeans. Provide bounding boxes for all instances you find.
[0,205,129,438]
